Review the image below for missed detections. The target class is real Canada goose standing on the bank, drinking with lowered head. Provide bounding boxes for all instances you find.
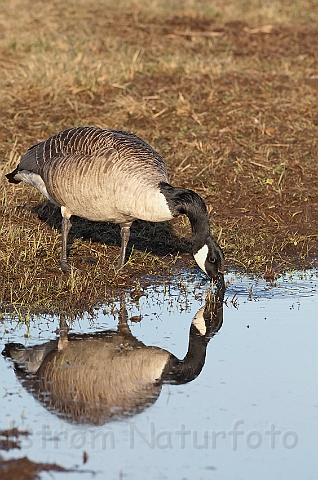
[6,127,224,281]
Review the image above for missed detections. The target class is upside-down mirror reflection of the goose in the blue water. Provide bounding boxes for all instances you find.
[2,293,223,425]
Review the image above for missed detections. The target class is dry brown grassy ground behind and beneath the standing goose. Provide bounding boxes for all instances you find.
[0,0,318,311]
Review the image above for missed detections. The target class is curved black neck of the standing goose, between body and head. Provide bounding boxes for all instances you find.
[159,183,210,245]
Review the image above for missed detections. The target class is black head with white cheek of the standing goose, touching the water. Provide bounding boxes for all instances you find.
[193,235,225,290]
